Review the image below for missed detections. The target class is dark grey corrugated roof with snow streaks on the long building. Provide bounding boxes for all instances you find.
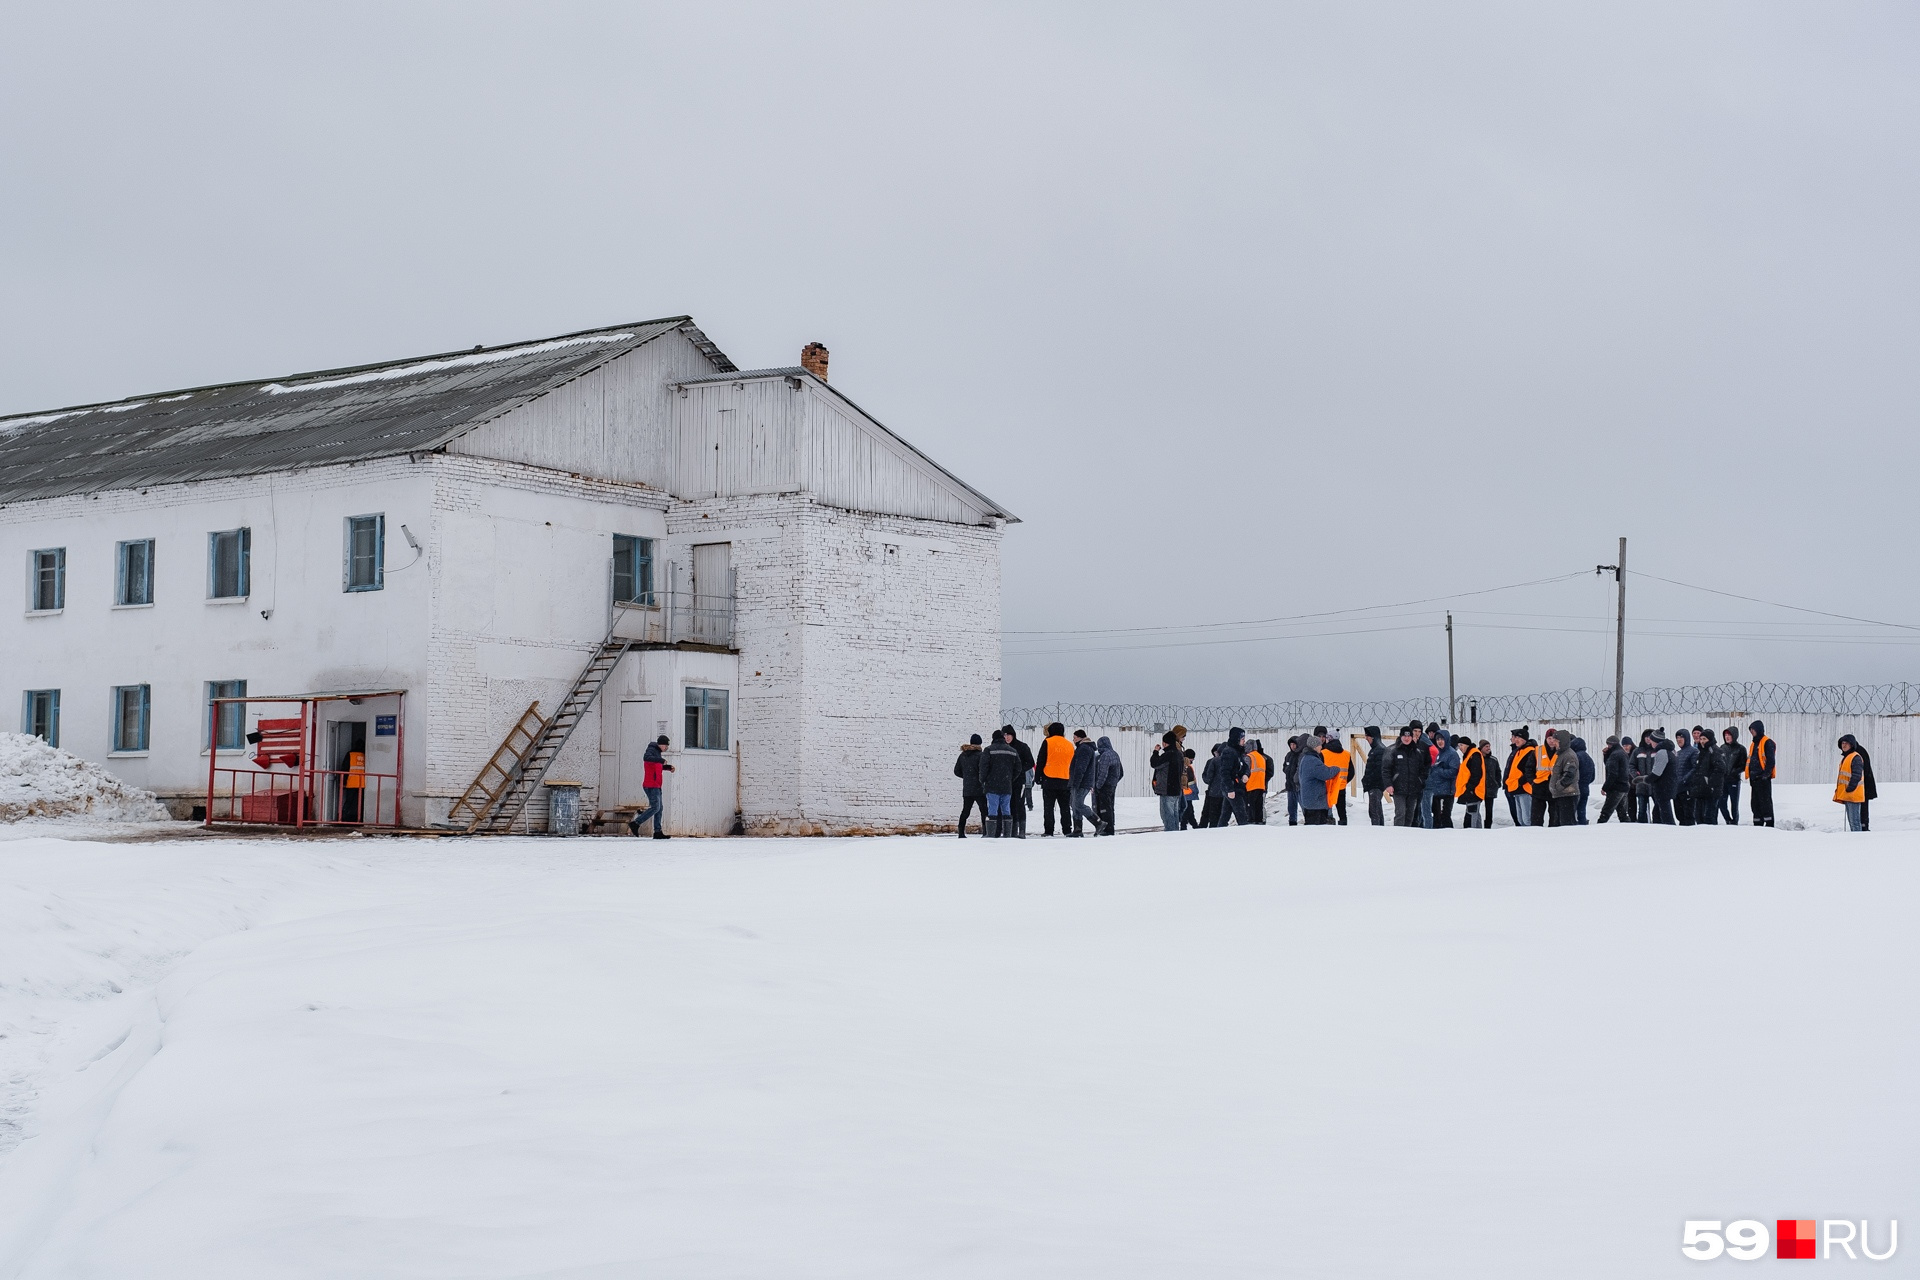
[0,315,733,503]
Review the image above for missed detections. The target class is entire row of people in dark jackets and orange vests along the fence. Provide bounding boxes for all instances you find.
[954,720,1880,837]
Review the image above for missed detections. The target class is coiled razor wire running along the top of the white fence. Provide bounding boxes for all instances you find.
[1000,681,1920,729]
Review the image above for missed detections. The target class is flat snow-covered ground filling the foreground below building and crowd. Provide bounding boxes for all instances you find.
[0,787,1920,1280]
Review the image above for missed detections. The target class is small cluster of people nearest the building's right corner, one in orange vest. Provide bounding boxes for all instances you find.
[954,722,1127,841]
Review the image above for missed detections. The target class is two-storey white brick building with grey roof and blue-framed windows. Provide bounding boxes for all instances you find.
[0,317,1012,835]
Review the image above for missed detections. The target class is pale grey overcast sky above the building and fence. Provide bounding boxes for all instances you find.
[0,2,1920,704]
